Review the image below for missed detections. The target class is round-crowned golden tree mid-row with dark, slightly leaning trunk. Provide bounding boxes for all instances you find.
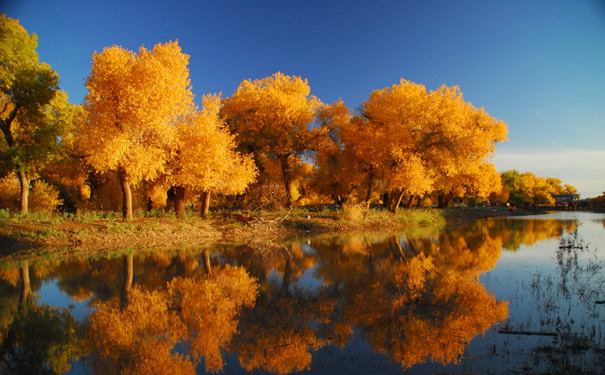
[221,72,321,207]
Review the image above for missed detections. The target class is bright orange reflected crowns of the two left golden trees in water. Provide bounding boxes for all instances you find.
[89,267,258,374]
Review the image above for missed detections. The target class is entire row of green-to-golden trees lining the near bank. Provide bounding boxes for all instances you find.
[0,15,576,218]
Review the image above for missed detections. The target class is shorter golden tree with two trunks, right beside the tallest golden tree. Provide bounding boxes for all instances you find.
[168,95,257,216]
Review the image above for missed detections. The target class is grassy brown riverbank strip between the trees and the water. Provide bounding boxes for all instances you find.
[0,207,544,258]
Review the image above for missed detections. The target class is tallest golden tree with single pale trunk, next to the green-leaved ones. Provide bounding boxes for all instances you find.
[78,42,194,219]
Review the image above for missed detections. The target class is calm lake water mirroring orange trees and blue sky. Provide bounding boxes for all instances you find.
[0,212,605,374]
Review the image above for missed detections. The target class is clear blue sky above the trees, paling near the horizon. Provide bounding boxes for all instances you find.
[0,0,605,198]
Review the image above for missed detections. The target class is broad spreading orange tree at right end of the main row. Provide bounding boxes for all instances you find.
[352,79,507,211]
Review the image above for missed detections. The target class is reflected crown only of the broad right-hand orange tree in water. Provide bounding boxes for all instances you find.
[347,254,508,367]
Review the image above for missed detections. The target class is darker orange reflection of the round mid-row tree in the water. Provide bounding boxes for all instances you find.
[226,244,330,374]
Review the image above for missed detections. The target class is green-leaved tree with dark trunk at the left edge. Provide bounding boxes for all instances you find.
[0,14,59,215]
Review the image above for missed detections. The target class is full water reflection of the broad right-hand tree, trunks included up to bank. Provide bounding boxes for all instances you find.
[313,226,508,367]
